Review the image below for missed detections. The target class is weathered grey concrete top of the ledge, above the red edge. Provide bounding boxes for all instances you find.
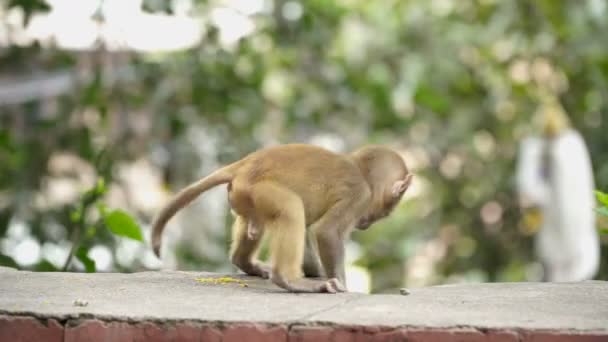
[0,269,608,341]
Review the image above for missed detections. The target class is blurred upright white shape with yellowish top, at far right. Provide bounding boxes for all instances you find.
[517,97,600,282]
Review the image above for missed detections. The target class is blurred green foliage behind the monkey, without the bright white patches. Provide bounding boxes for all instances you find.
[0,0,608,290]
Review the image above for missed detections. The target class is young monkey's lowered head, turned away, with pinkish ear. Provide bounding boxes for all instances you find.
[351,146,412,230]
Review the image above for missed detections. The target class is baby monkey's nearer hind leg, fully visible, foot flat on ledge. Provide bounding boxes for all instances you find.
[252,183,344,293]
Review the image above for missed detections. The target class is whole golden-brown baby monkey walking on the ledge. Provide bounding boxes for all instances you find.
[152,144,412,293]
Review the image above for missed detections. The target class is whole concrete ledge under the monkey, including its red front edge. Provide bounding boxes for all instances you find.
[0,269,608,341]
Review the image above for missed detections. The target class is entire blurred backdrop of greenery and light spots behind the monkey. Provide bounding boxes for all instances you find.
[0,0,608,292]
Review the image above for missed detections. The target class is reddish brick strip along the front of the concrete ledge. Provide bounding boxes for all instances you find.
[0,315,608,342]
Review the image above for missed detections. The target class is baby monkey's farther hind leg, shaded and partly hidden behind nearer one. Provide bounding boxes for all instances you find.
[230,215,270,279]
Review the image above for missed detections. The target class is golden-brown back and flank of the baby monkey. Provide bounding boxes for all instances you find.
[233,144,368,222]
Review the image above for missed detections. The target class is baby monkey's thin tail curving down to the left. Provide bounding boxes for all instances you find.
[152,162,239,257]
